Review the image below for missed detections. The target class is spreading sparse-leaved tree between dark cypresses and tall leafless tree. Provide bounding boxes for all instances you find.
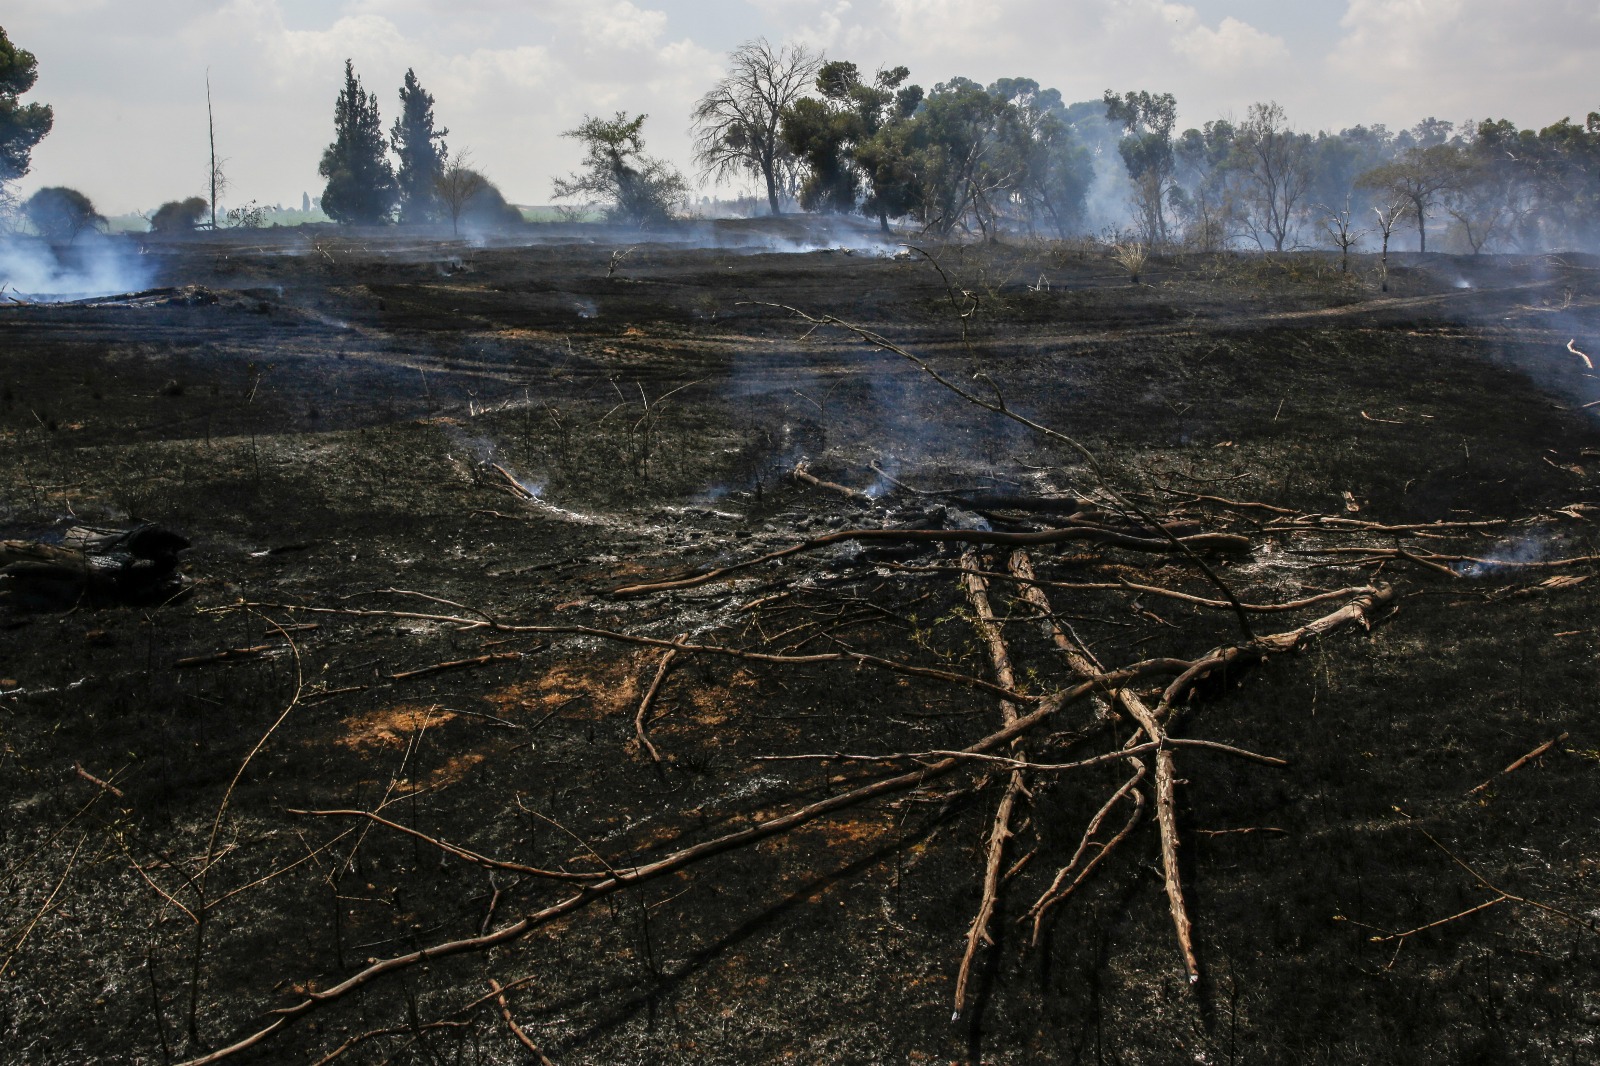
[554,110,688,226]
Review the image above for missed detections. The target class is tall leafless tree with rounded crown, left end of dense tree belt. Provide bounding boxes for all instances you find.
[693,38,822,214]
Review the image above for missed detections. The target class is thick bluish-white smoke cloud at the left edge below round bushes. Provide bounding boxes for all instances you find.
[0,232,155,303]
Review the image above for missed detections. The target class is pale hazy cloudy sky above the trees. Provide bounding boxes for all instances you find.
[0,0,1600,213]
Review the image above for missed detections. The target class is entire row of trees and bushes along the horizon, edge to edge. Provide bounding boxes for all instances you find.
[0,21,1600,256]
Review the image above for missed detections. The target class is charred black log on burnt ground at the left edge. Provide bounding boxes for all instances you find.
[0,523,189,599]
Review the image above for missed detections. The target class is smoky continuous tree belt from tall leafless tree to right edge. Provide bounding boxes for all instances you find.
[694,40,1600,254]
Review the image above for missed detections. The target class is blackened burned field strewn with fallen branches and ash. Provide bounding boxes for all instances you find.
[0,229,1600,1063]
